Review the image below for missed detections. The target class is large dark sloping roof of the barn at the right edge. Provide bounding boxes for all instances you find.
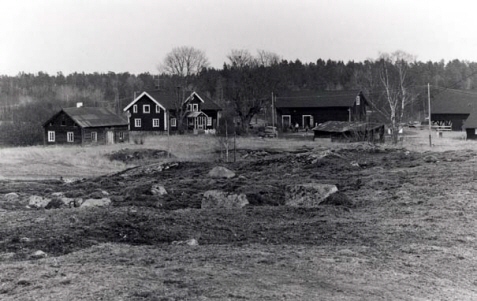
[425,87,477,114]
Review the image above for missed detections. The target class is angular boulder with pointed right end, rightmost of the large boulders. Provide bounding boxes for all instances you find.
[285,183,338,208]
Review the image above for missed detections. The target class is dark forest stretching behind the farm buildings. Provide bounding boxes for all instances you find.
[0,59,477,145]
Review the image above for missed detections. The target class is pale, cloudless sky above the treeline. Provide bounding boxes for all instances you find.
[0,0,477,75]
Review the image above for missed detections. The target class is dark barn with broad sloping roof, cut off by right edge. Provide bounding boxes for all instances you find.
[426,88,477,131]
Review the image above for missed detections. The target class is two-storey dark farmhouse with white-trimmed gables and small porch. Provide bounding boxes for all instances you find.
[124,90,221,132]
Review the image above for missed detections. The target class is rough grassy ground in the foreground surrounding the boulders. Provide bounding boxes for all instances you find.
[0,144,477,300]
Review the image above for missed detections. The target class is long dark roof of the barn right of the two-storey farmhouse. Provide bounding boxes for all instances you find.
[275,90,366,108]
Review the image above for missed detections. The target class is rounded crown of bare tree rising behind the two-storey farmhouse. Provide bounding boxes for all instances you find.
[159,46,209,79]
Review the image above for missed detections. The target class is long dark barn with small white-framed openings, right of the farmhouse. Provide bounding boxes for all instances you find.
[275,90,368,129]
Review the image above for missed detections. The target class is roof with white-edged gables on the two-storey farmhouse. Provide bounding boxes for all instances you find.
[123,90,221,111]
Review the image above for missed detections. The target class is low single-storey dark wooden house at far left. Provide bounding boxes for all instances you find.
[43,107,129,145]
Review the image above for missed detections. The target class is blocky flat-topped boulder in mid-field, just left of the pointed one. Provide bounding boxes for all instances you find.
[201,190,249,209]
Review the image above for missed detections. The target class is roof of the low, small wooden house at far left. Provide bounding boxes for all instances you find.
[43,107,128,128]
